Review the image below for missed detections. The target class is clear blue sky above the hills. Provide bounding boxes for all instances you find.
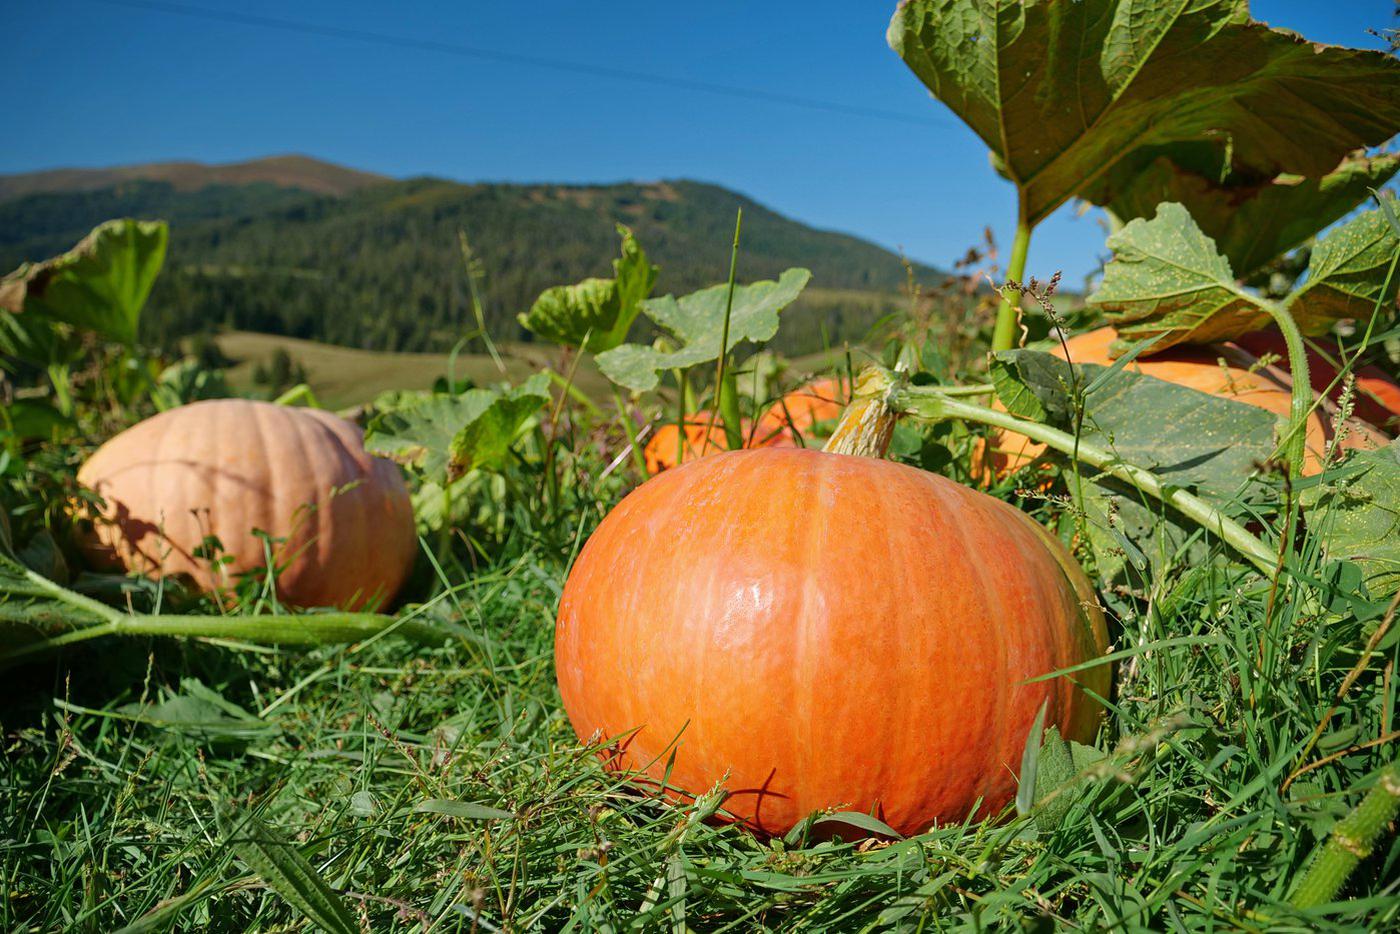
[0,0,1394,284]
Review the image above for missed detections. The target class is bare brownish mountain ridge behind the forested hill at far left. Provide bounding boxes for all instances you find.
[0,155,389,202]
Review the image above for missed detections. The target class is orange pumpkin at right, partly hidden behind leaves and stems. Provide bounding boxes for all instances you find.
[988,326,1386,476]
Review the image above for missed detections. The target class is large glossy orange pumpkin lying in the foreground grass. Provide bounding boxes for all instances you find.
[554,448,1110,833]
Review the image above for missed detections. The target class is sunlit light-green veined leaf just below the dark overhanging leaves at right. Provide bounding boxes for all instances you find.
[1088,202,1282,350]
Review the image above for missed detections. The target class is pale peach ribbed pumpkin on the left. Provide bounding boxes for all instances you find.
[78,399,417,609]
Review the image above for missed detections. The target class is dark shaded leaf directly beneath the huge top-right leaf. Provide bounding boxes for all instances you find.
[1084,141,1400,279]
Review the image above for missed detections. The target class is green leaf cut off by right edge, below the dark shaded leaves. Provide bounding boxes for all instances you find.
[1287,210,1400,332]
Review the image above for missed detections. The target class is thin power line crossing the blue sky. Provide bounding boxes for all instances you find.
[81,0,948,127]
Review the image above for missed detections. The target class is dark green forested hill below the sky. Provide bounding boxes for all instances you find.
[0,157,942,353]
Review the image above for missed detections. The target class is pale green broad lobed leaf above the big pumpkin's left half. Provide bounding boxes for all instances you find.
[598,269,812,392]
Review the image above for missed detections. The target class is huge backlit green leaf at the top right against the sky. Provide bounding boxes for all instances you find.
[889,0,1400,224]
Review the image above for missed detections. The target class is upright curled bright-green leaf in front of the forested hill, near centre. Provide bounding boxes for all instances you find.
[519,224,658,353]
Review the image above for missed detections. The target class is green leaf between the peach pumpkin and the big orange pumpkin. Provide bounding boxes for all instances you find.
[365,372,550,480]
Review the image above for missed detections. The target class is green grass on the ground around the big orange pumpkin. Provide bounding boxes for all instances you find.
[0,470,1400,931]
